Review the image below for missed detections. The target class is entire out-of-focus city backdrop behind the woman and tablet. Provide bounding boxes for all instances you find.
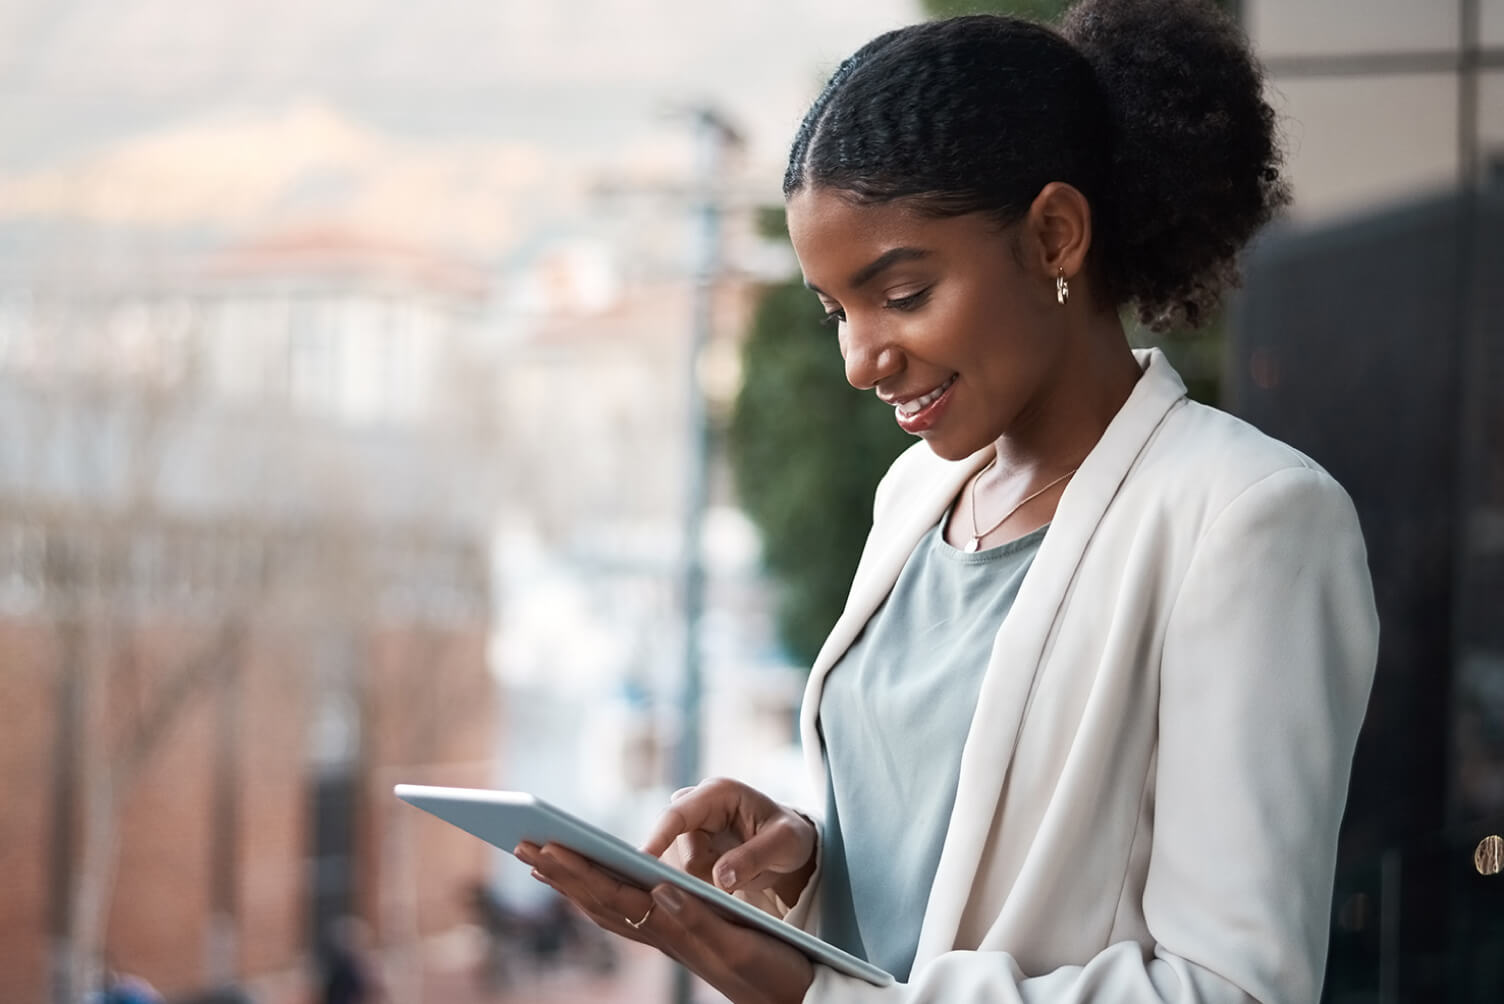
[0,0,1504,1004]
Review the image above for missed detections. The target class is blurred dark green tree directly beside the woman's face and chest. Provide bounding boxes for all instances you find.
[728,207,913,664]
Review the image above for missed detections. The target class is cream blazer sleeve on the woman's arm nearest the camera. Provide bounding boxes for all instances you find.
[805,467,1378,1004]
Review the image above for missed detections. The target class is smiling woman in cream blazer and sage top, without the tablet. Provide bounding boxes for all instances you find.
[519,0,1378,1004]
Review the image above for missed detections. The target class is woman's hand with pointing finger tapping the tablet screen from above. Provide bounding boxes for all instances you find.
[642,777,817,905]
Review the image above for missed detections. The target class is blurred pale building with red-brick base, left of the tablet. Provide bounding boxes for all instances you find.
[0,230,499,1001]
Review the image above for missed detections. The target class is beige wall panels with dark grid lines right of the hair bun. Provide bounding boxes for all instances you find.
[1239,0,1504,222]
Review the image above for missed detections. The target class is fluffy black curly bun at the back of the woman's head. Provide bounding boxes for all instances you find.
[1060,0,1289,328]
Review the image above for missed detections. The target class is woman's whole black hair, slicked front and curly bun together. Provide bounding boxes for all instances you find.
[784,0,1289,329]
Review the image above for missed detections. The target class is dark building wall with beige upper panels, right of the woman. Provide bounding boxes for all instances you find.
[1224,0,1504,1004]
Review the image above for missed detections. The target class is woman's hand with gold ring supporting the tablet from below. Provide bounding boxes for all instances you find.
[516,843,815,1004]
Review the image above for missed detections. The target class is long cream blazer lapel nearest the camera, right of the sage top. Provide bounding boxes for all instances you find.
[908,349,1185,968]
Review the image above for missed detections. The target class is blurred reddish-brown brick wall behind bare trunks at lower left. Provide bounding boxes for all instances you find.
[0,621,498,1004]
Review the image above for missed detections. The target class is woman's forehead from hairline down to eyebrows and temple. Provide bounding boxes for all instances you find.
[787,188,1006,292]
